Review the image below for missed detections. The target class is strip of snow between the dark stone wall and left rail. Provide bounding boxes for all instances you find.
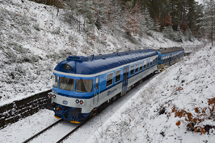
[0,110,57,143]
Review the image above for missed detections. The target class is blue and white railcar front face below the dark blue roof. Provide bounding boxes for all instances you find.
[50,71,94,123]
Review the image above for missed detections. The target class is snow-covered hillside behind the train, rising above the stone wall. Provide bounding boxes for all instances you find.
[0,0,199,105]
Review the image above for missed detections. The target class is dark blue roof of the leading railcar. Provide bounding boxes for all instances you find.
[54,49,158,75]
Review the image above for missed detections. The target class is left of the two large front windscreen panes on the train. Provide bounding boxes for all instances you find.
[59,77,74,91]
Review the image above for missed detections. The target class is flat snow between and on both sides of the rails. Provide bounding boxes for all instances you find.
[0,77,154,143]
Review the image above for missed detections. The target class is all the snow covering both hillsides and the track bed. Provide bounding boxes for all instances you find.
[0,0,215,143]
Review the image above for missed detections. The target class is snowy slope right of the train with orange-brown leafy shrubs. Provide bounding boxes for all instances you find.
[88,46,215,143]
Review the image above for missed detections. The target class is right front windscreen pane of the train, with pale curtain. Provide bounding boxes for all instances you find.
[75,79,93,92]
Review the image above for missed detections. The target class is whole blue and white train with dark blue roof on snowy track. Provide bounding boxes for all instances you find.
[48,47,184,124]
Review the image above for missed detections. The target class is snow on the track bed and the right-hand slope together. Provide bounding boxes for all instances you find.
[0,46,215,143]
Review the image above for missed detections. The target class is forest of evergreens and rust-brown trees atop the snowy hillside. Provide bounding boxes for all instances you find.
[33,0,215,44]
